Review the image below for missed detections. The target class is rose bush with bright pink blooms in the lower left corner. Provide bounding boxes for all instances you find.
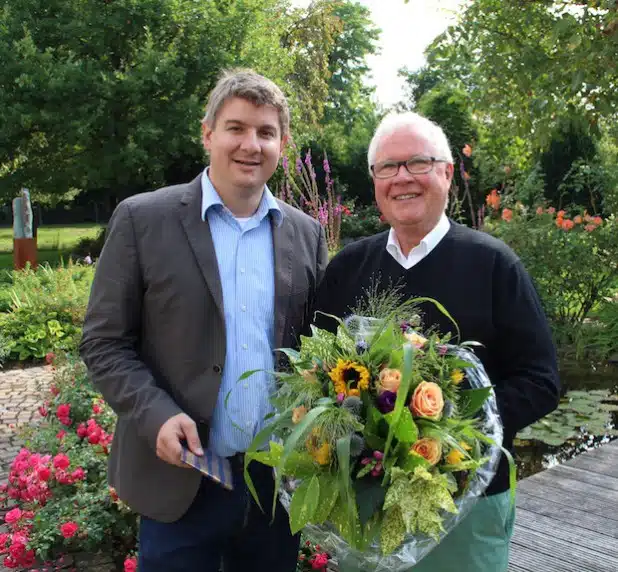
[0,363,137,568]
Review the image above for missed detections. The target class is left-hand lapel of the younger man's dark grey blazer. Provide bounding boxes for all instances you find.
[180,174,225,323]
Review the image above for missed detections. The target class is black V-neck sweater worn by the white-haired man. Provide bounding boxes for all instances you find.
[315,221,560,494]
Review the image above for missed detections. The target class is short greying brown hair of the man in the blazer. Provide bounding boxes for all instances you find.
[202,69,290,137]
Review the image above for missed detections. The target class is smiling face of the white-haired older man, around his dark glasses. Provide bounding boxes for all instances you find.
[373,126,453,232]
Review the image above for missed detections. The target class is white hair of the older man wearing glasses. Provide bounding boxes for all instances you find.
[367,111,453,170]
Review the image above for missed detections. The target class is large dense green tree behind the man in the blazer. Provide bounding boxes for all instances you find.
[0,0,338,200]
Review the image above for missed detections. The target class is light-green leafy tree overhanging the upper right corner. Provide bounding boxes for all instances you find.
[410,0,618,150]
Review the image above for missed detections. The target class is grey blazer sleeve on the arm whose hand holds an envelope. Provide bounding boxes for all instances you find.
[79,201,182,449]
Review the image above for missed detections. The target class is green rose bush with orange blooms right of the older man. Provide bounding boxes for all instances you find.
[484,201,618,342]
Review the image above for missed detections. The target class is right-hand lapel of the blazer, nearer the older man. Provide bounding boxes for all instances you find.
[270,216,296,348]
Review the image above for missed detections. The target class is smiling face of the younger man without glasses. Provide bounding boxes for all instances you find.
[202,97,285,195]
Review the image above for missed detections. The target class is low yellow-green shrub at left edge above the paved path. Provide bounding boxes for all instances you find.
[0,262,94,361]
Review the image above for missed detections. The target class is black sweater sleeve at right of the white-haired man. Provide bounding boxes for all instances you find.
[492,259,560,436]
